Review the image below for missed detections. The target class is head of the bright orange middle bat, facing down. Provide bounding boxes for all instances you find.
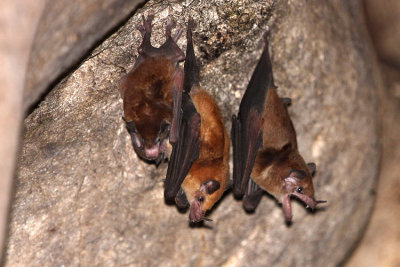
[189,180,220,223]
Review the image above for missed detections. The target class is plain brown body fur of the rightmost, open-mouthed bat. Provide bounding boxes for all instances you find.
[251,88,314,201]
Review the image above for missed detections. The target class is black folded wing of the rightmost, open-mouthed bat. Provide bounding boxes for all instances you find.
[231,34,275,197]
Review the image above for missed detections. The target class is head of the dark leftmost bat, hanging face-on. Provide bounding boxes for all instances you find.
[127,120,170,165]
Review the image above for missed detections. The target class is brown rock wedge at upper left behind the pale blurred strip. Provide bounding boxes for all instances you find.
[24,0,144,109]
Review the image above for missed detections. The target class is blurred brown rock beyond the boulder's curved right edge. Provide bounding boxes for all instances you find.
[346,0,400,267]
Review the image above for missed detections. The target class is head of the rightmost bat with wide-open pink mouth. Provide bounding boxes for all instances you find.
[282,163,326,222]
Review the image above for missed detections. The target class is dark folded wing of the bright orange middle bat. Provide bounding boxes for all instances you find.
[164,93,201,201]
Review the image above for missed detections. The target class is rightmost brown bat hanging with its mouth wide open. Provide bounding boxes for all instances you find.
[231,30,325,222]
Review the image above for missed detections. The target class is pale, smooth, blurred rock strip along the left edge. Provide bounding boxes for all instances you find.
[0,0,44,260]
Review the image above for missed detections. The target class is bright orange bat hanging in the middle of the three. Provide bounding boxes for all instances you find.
[164,19,230,223]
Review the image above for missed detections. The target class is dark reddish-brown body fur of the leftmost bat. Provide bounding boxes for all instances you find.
[121,58,176,146]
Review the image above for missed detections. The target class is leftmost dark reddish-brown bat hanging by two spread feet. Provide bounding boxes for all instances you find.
[120,15,185,165]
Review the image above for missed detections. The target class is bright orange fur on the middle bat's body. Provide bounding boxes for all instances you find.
[182,90,230,212]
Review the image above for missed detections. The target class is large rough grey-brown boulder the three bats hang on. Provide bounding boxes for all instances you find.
[6,0,379,266]
